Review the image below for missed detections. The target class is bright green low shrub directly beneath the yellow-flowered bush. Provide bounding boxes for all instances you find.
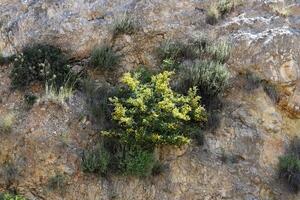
[120,146,155,177]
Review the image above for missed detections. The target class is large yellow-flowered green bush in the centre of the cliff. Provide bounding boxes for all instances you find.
[102,71,206,146]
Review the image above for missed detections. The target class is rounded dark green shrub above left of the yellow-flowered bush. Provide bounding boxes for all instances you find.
[91,44,120,70]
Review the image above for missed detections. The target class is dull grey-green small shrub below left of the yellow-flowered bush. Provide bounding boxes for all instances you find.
[82,143,110,175]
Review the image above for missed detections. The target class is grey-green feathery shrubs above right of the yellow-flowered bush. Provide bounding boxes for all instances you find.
[158,38,230,130]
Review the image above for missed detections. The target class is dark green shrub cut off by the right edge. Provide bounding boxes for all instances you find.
[278,138,300,192]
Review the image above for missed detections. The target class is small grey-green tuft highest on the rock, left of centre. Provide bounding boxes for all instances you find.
[113,14,137,37]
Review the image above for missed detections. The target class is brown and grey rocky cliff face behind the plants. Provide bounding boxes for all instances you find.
[0,0,300,200]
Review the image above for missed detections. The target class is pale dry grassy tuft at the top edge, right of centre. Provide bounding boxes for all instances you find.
[206,0,243,25]
